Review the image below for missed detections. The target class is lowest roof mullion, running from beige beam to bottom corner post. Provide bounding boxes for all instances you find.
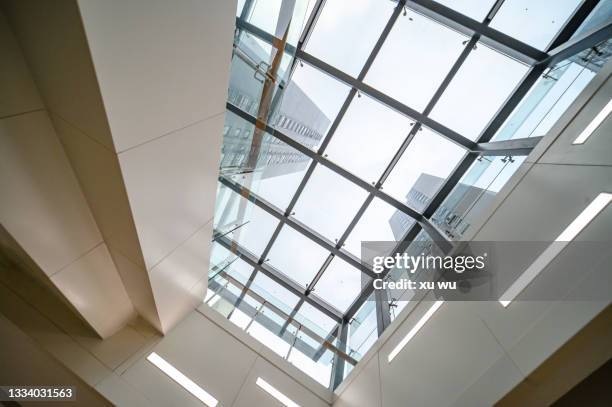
[218,237,342,322]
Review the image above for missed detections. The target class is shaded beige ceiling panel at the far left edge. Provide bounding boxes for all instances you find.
[0,9,134,337]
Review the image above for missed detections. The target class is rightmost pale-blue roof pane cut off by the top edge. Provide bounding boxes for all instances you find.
[491,0,581,49]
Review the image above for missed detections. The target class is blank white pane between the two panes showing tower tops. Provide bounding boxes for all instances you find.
[325,96,411,182]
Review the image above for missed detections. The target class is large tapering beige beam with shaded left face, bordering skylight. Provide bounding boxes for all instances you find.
[2,0,236,332]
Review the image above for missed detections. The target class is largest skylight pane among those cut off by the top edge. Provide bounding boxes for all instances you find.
[306,0,397,77]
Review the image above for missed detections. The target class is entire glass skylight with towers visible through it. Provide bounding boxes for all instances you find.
[205,0,611,387]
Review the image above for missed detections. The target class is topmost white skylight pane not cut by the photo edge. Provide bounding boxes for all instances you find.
[365,11,469,111]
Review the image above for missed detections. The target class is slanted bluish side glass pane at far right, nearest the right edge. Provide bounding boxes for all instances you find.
[492,44,612,141]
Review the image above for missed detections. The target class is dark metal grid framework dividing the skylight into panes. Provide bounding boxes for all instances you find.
[215,0,612,387]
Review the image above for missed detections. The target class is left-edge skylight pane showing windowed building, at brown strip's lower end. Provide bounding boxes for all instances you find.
[221,112,311,214]
